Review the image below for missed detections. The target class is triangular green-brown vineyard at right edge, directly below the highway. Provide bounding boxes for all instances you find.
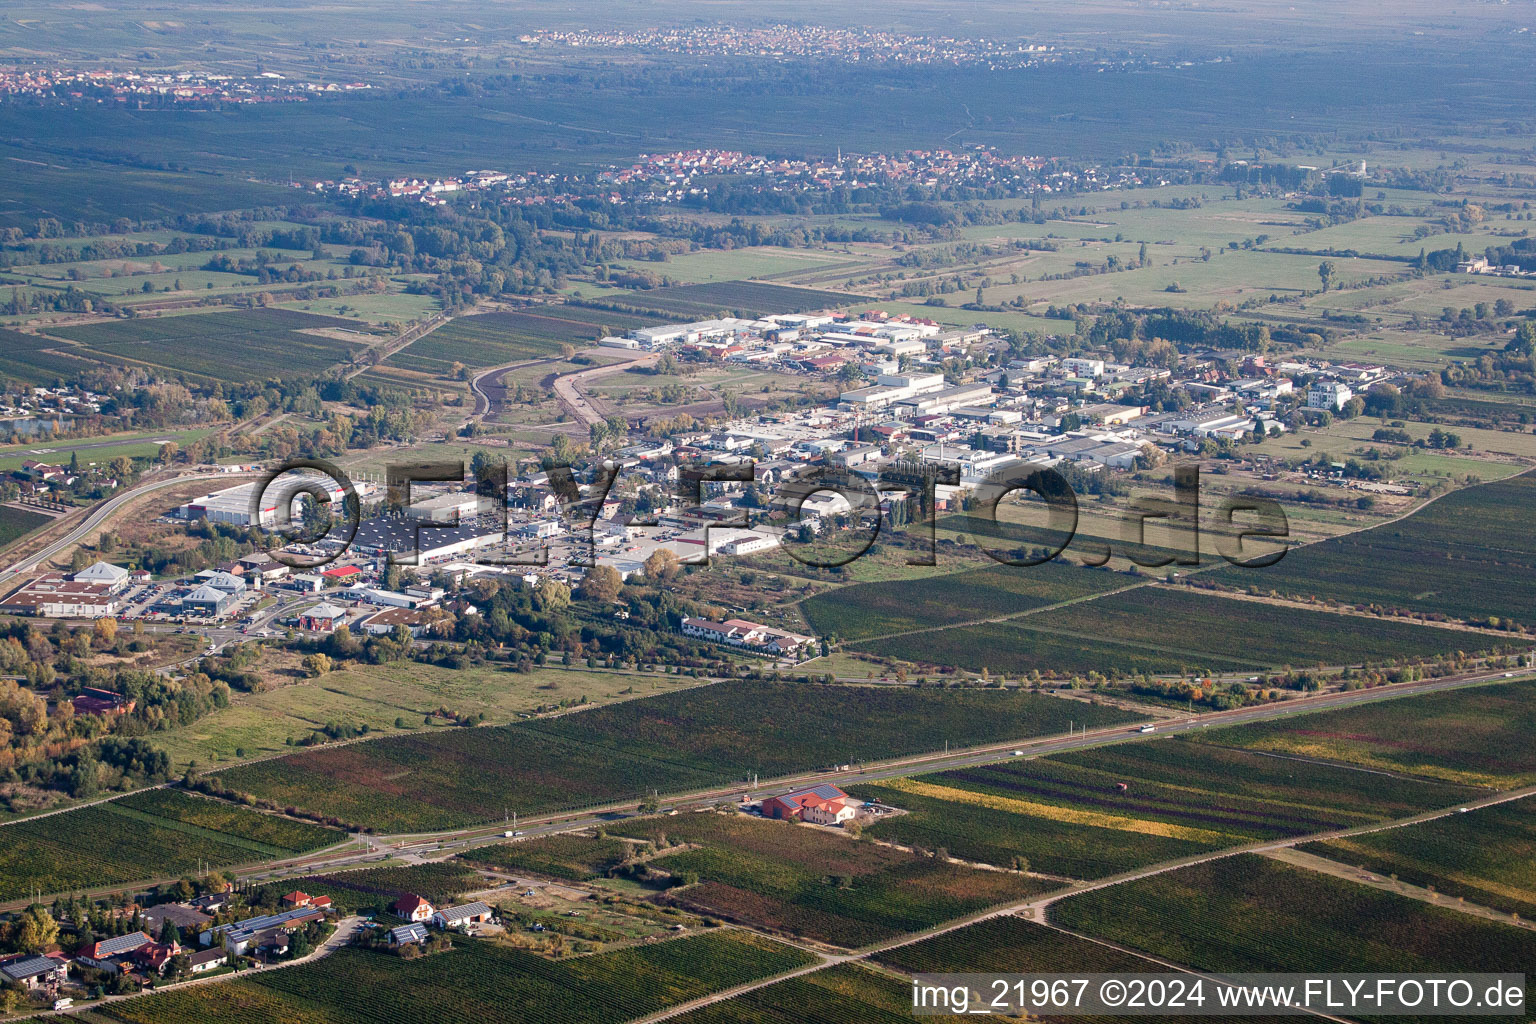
[1201,680,1536,789]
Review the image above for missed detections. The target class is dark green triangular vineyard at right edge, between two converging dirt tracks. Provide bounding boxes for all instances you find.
[1301,798,1536,918]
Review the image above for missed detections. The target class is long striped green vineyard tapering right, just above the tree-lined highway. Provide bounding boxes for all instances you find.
[854,580,1504,676]
